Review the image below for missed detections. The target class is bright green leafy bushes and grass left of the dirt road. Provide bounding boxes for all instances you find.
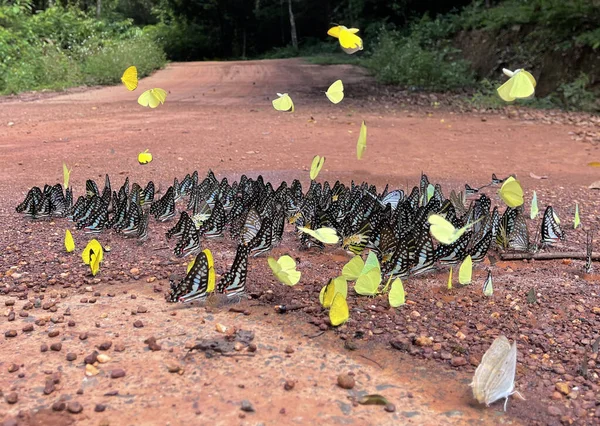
[0,5,165,93]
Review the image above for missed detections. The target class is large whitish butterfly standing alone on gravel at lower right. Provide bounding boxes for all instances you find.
[470,336,525,411]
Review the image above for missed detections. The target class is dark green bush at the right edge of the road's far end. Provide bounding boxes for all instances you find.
[368,31,475,90]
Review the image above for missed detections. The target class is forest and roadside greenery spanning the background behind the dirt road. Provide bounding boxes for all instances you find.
[0,0,600,112]
